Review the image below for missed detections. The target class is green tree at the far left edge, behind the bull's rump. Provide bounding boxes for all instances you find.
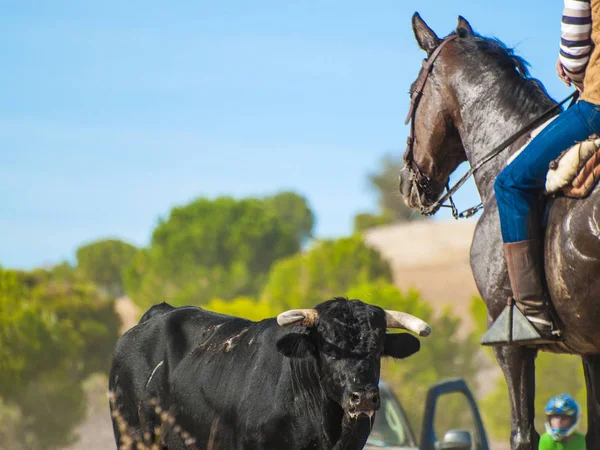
[0,267,119,450]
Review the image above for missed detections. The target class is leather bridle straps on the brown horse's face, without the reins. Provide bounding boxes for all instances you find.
[404,34,456,215]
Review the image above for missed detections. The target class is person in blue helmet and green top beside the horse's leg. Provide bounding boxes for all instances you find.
[538,394,585,450]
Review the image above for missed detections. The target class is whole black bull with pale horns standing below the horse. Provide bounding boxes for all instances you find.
[109,298,430,450]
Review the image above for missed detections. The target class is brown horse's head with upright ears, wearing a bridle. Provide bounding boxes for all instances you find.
[400,13,473,213]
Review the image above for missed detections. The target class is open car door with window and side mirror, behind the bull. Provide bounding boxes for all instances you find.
[419,378,489,450]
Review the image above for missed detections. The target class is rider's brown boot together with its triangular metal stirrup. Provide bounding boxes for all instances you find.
[481,240,560,345]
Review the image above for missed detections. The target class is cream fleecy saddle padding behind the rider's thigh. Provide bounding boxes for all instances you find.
[545,135,600,198]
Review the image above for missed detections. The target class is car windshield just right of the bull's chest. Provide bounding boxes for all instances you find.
[367,389,410,447]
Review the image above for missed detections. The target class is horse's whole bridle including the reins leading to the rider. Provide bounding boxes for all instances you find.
[404,34,579,219]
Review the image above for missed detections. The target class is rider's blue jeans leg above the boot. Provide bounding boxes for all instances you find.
[494,100,600,243]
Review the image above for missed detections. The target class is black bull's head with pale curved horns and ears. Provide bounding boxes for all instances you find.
[277,298,430,420]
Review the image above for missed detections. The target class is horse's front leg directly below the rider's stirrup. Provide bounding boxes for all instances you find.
[494,346,540,450]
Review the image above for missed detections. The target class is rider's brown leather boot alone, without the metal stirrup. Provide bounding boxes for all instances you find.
[504,240,556,340]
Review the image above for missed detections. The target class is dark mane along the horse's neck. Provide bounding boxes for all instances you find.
[456,33,556,114]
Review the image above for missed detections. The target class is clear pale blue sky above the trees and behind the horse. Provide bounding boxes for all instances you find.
[0,0,569,268]
